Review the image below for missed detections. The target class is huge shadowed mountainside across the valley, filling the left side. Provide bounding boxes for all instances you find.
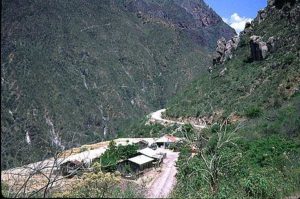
[1,0,235,168]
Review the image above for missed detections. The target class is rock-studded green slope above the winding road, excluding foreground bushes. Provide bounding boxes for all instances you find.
[167,0,300,135]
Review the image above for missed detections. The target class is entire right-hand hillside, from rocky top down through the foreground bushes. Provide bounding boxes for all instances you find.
[166,0,300,199]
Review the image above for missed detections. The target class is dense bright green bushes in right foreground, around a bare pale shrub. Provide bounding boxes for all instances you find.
[172,125,300,198]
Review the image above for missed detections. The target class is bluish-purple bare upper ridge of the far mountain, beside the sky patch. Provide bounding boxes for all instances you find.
[125,0,236,49]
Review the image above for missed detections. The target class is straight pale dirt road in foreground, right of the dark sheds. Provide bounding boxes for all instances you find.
[147,149,179,198]
